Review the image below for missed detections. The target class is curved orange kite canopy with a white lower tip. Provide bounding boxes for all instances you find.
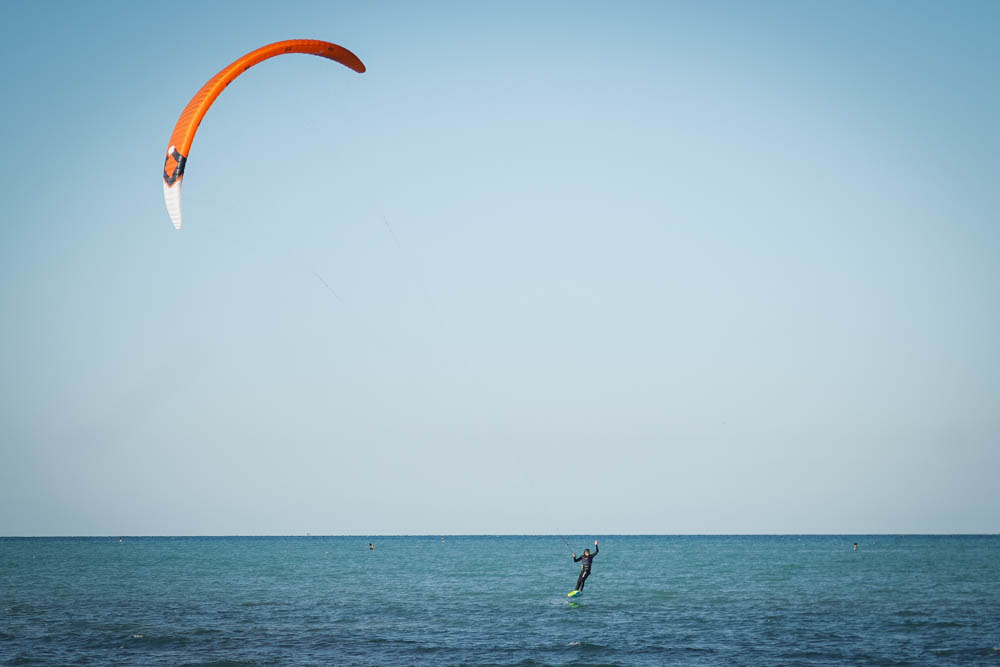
[163,39,365,229]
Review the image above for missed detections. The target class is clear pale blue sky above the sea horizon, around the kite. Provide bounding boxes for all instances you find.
[0,1,1000,535]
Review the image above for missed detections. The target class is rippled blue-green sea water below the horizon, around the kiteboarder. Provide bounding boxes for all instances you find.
[0,535,1000,665]
